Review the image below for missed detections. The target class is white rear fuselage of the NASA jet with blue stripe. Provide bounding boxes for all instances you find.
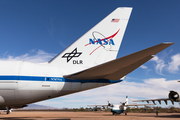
[0,61,120,106]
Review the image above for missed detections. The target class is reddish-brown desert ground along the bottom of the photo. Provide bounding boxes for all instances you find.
[0,111,180,120]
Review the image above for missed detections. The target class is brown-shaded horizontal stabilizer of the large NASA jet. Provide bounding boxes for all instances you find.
[63,43,173,80]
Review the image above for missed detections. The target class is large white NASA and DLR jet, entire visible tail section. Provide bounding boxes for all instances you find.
[0,8,173,113]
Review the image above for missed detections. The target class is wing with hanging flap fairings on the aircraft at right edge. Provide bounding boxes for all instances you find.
[133,98,174,105]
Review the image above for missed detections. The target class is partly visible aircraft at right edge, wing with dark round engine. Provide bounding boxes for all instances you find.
[133,81,180,105]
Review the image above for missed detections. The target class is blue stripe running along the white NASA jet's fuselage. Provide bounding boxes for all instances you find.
[0,76,122,83]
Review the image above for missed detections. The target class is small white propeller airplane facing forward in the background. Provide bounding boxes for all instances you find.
[88,96,155,115]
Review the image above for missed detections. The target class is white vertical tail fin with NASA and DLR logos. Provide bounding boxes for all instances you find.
[49,7,132,71]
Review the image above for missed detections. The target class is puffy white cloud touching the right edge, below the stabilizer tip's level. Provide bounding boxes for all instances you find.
[168,53,180,73]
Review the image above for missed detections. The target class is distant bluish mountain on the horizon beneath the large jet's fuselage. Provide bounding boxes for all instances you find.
[22,104,59,110]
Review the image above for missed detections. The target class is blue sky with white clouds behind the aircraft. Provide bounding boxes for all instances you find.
[0,0,180,108]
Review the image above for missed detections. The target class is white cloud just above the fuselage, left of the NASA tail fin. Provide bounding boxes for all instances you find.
[0,50,55,63]
